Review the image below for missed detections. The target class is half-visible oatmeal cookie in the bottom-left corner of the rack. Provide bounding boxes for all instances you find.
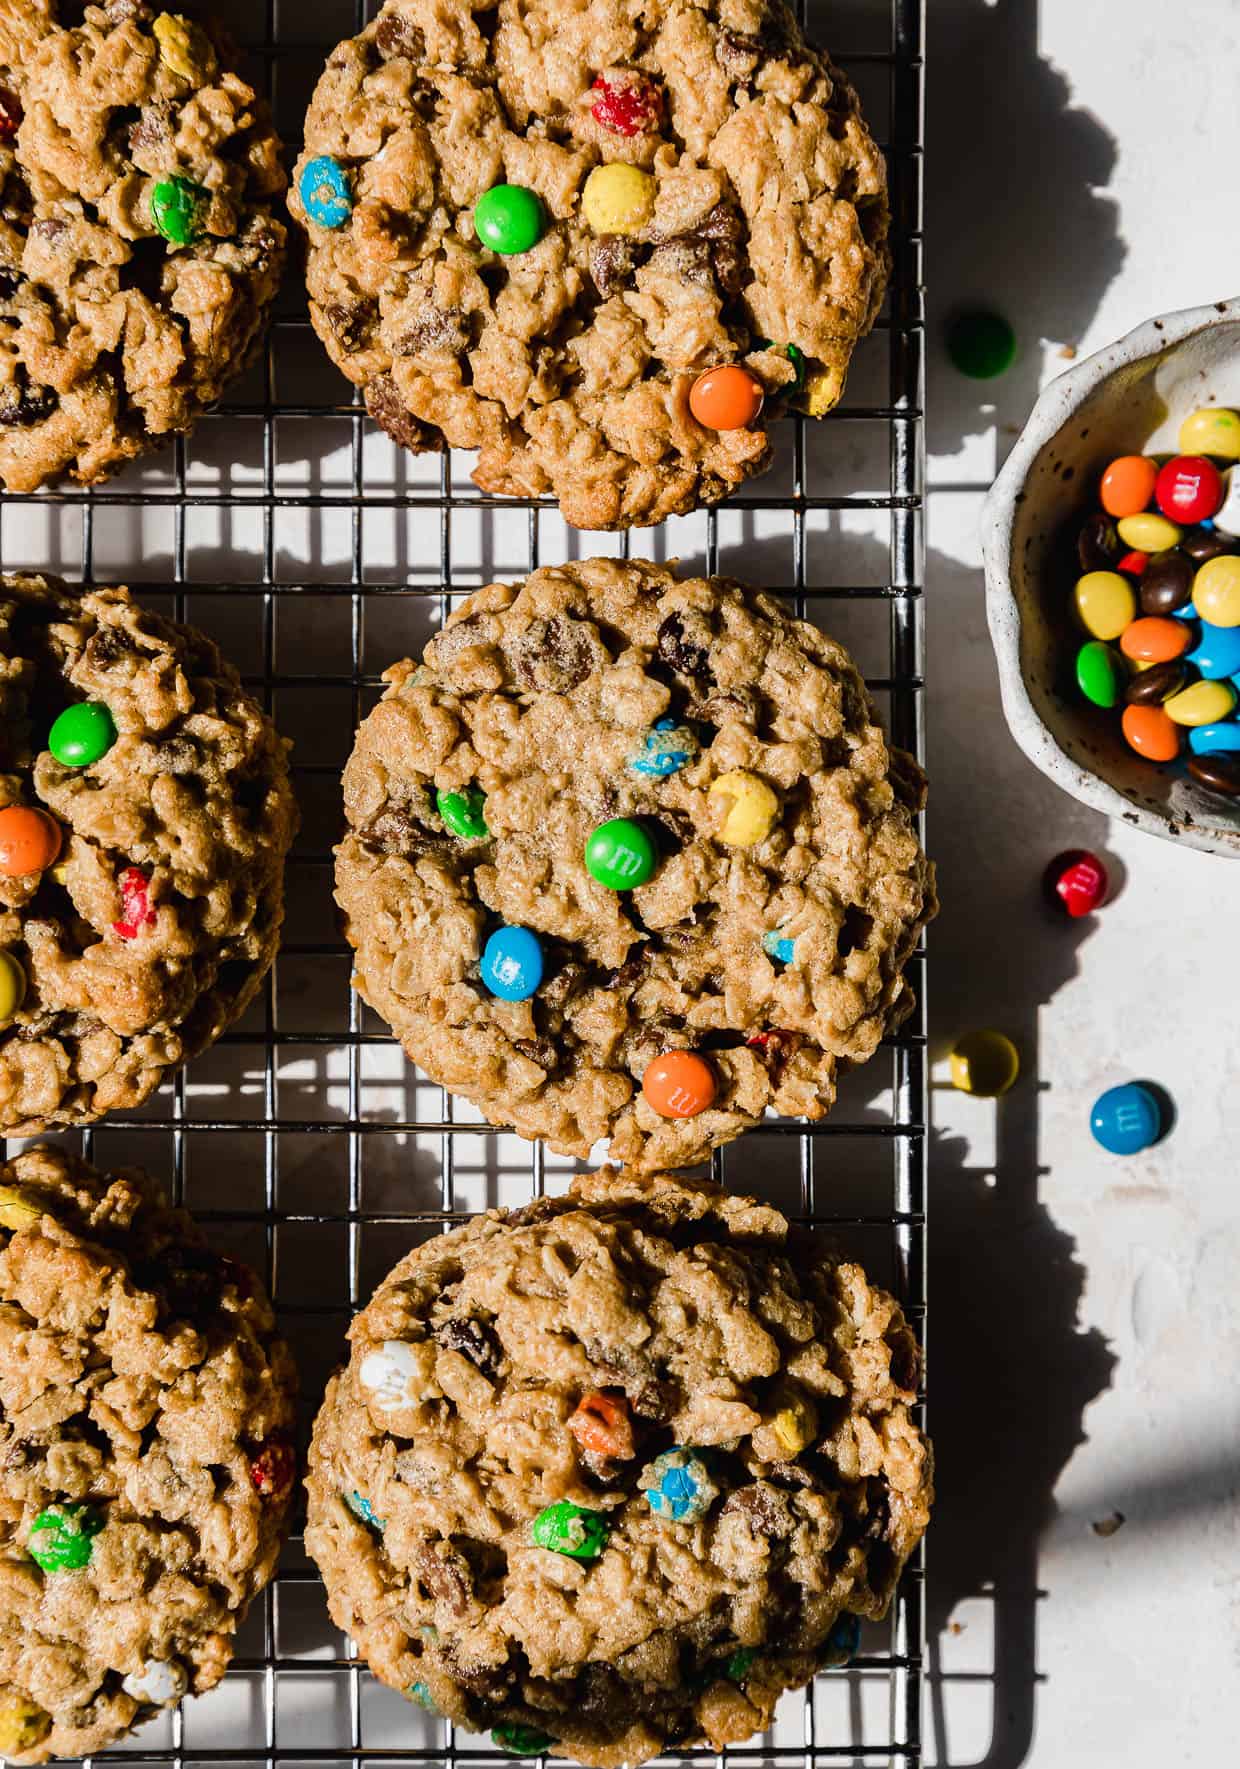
[0,1148,295,1764]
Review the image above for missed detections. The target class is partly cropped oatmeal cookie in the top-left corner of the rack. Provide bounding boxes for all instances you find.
[0,0,285,492]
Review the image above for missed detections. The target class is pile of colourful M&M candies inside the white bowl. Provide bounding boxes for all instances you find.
[1072,407,1240,798]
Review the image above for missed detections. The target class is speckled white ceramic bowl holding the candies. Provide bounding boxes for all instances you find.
[982,297,1240,858]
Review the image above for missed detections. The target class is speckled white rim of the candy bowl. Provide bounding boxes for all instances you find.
[982,295,1240,860]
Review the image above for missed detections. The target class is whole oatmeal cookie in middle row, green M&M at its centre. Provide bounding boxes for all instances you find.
[336,559,936,1168]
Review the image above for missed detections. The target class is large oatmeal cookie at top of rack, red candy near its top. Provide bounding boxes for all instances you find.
[290,0,888,529]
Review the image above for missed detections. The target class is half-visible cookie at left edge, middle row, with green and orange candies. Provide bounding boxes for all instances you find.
[0,577,295,1136]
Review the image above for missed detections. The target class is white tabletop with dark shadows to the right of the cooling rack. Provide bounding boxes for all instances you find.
[927,0,1240,1769]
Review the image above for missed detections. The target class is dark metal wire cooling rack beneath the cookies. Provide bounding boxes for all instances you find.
[0,0,927,1769]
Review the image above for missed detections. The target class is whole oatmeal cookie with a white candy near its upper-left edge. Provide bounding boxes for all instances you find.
[306,1175,930,1769]
